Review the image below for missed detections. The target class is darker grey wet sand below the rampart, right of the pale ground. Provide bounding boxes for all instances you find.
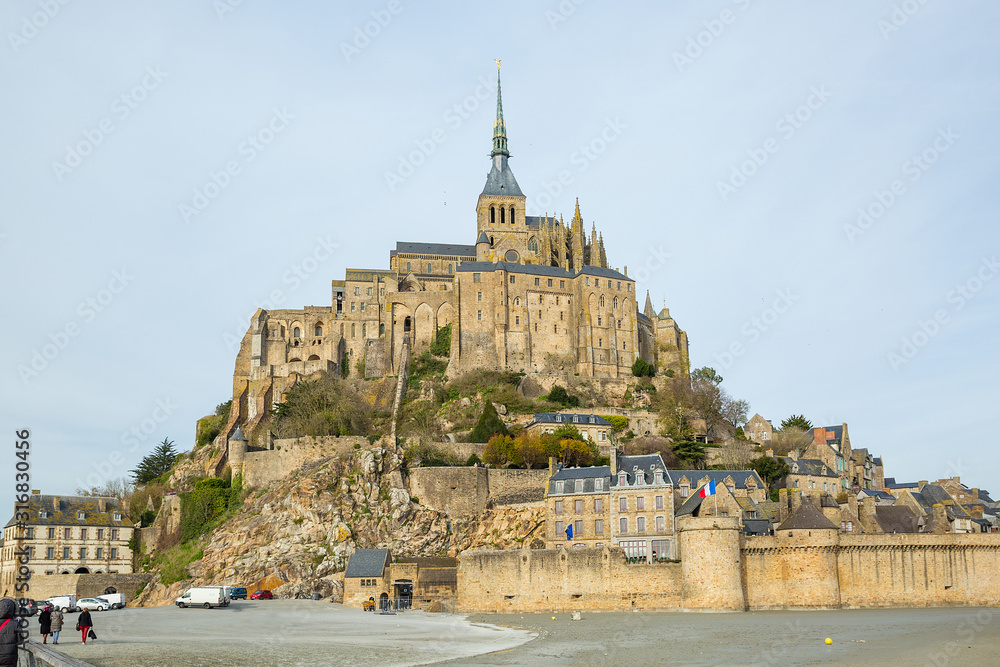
[442,607,1000,667]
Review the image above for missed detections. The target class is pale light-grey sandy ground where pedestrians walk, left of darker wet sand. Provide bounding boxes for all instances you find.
[19,600,536,667]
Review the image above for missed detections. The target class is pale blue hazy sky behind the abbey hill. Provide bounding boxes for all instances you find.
[0,0,1000,502]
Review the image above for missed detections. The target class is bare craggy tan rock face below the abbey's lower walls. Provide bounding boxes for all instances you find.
[137,447,544,606]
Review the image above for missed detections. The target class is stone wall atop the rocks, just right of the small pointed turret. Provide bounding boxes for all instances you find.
[243,436,369,488]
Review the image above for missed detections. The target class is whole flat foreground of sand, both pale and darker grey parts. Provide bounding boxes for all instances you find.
[21,600,1000,667]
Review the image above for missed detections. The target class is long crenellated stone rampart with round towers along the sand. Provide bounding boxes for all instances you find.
[458,517,1000,612]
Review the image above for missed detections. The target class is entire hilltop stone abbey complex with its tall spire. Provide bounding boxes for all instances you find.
[233,72,688,444]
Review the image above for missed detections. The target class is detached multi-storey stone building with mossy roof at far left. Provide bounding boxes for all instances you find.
[0,491,135,595]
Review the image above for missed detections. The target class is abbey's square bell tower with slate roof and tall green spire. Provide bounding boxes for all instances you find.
[476,60,532,263]
